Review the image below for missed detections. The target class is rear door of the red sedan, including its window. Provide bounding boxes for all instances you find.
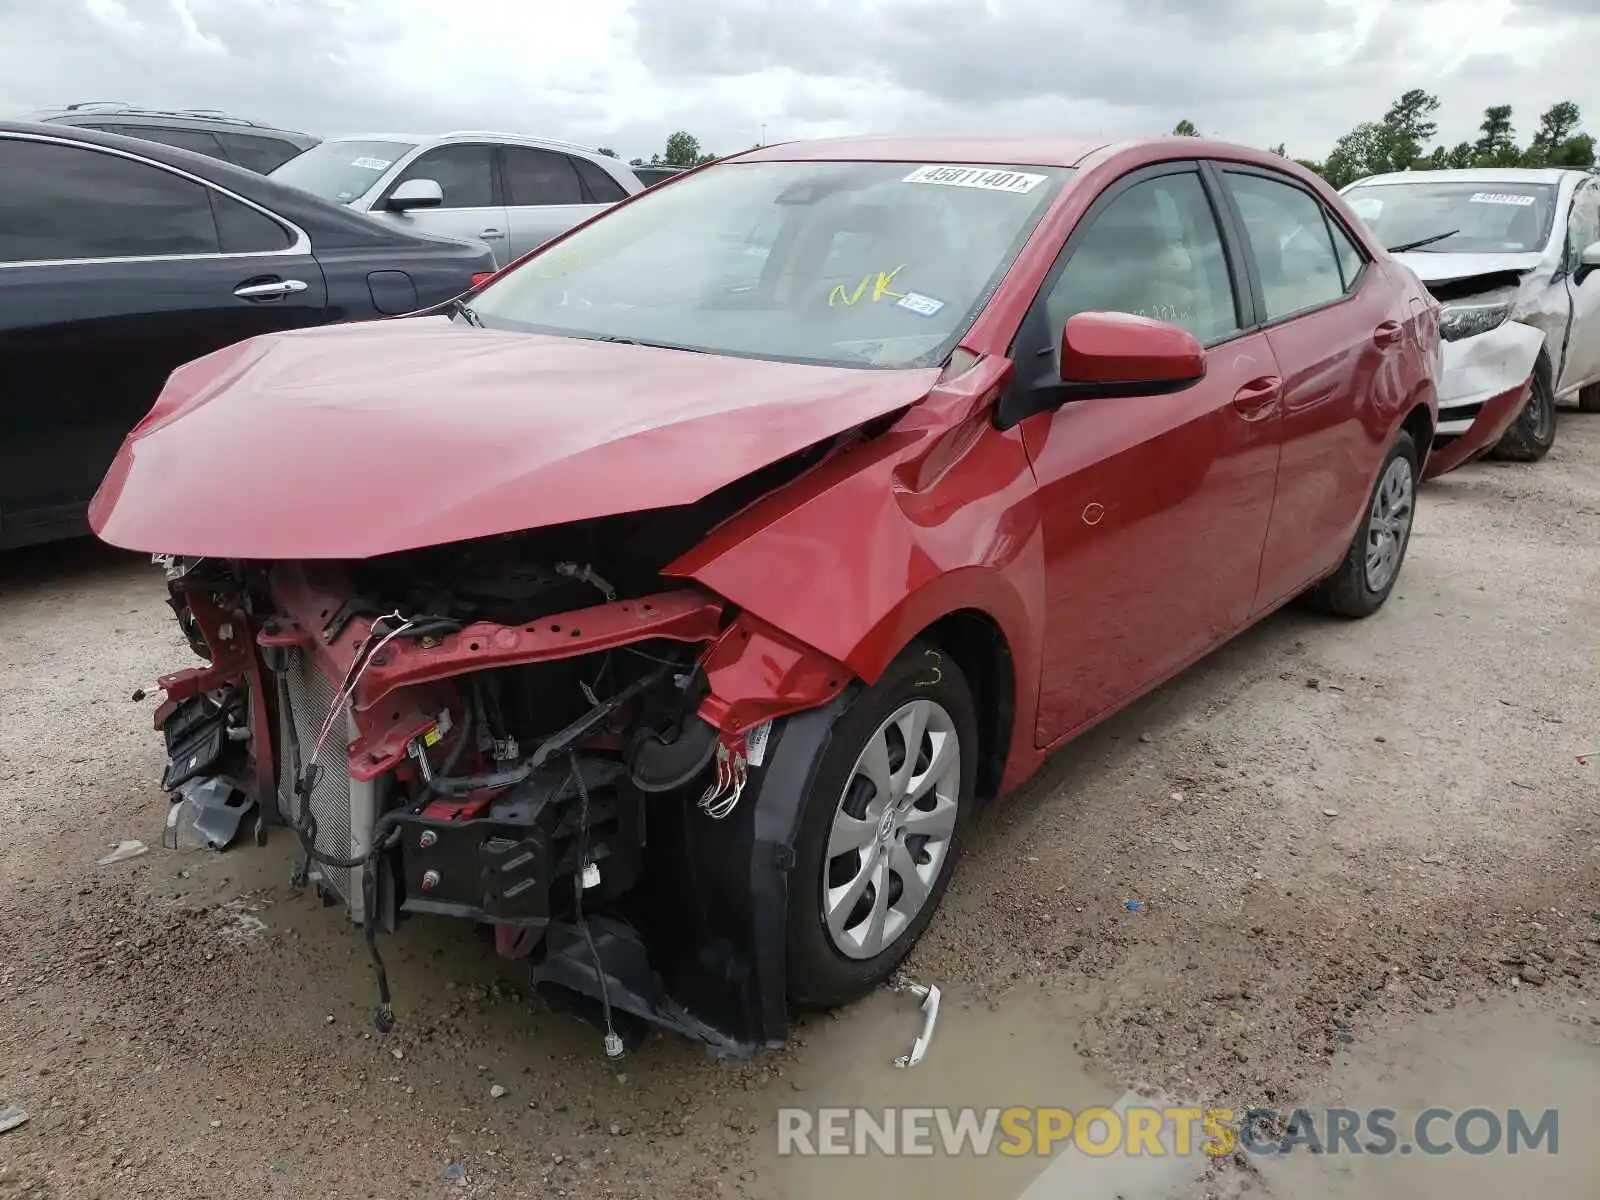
[1214,163,1411,613]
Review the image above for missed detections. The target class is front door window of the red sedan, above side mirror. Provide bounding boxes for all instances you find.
[1045,171,1240,344]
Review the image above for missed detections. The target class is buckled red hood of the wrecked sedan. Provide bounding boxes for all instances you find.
[90,317,938,558]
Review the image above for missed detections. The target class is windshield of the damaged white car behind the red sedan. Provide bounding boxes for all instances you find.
[1344,179,1555,254]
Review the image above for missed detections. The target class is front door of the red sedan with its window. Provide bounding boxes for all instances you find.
[1014,163,1280,746]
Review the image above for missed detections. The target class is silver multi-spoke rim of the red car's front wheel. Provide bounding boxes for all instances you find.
[822,699,962,958]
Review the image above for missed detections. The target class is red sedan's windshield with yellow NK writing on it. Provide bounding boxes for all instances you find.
[472,162,1072,368]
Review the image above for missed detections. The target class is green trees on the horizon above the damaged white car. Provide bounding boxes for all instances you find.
[1173,88,1595,187]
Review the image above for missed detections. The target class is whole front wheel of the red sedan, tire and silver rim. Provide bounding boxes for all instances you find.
[787,643,978,1008]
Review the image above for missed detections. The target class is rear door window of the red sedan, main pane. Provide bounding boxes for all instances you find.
[1224,171,1344,320]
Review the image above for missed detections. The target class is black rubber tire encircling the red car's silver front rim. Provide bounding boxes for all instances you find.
[787,642,978,1008]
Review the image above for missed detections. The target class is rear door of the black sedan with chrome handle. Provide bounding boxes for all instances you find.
[0,136,326,544]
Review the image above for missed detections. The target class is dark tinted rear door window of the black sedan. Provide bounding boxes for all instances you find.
[0,138,219,262]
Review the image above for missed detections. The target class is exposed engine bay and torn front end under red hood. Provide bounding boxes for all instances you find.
[147,483,848,1058]
